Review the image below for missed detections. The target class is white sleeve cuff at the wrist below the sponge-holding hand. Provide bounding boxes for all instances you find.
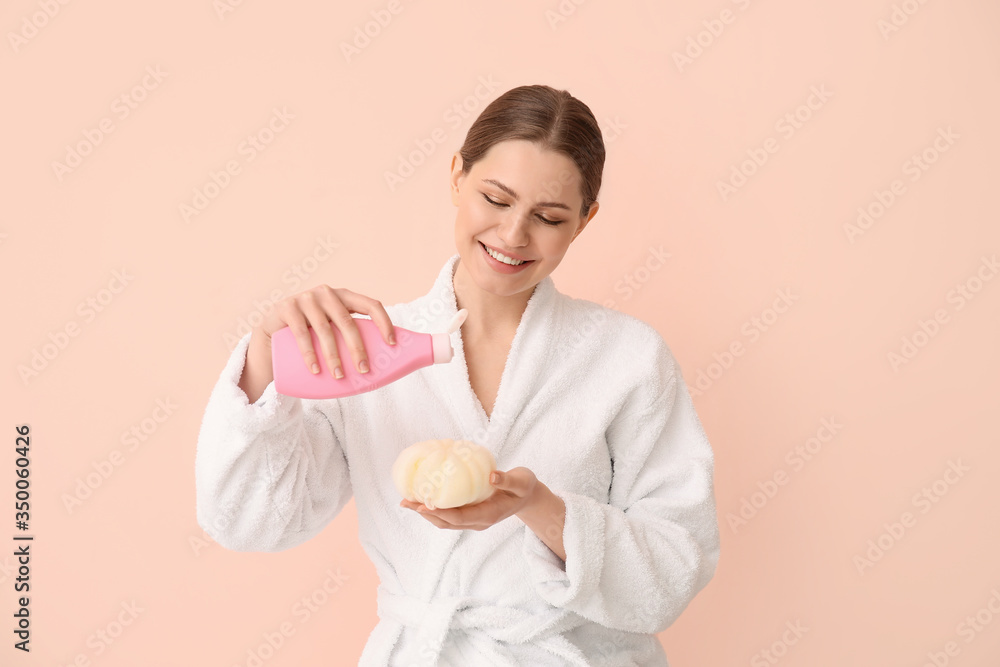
[521,490,605,607]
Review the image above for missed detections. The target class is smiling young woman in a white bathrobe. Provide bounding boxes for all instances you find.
[196,85,719,667]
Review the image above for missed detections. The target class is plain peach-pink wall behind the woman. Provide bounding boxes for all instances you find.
[0,0,1000,667]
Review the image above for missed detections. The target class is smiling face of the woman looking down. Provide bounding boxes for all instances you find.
[451,140,598,296]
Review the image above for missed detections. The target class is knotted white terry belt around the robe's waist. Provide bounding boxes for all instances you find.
[378,586,590,667]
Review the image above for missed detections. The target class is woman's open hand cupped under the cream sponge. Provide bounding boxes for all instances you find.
[399,466,538,530]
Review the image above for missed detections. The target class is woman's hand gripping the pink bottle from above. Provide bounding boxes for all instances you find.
[254,285,395,377]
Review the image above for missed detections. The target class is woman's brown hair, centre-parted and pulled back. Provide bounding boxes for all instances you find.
[459,85,604,216]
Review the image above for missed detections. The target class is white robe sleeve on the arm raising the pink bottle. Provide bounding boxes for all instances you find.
[195,334,353,552]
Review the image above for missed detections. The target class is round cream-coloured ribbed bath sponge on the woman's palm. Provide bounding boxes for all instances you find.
[392,438,496,509]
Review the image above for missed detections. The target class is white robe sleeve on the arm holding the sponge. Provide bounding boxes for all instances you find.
[522,339,719,634]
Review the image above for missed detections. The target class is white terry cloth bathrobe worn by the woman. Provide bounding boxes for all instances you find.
[196,254,719,667]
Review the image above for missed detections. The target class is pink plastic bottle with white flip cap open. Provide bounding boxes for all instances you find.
[271,308,468,398]
